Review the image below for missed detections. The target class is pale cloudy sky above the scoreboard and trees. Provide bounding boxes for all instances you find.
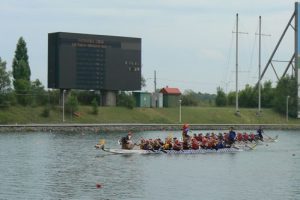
[0,0,295,93]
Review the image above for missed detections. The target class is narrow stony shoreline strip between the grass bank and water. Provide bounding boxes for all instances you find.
[0,124,300,133]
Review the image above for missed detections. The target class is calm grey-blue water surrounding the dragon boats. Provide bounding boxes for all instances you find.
[0,131,300,200]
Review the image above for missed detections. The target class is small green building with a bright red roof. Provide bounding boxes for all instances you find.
[160,87,181,107]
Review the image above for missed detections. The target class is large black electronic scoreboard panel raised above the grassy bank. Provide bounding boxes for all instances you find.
[48,32,141,91]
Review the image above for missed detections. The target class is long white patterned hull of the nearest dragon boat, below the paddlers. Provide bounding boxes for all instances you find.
[95,144,256,154]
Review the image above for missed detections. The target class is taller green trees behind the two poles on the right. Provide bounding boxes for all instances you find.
[215,75,298,117]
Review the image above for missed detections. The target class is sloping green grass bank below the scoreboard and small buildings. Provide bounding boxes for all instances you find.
[0,106,300,124]
